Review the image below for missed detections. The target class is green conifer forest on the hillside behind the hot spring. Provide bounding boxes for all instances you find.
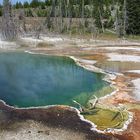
[0,0,140,37]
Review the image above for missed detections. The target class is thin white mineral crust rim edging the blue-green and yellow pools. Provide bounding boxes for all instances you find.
[1,51,133,134]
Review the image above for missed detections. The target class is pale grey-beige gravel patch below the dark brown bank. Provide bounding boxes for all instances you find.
[0,121,86,140]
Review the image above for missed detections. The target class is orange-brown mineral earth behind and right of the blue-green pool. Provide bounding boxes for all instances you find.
[27,37,140,140]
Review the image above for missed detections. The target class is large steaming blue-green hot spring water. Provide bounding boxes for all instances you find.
[0,53,107,107]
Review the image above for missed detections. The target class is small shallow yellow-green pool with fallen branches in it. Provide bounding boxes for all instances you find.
[83,108,128,130]
